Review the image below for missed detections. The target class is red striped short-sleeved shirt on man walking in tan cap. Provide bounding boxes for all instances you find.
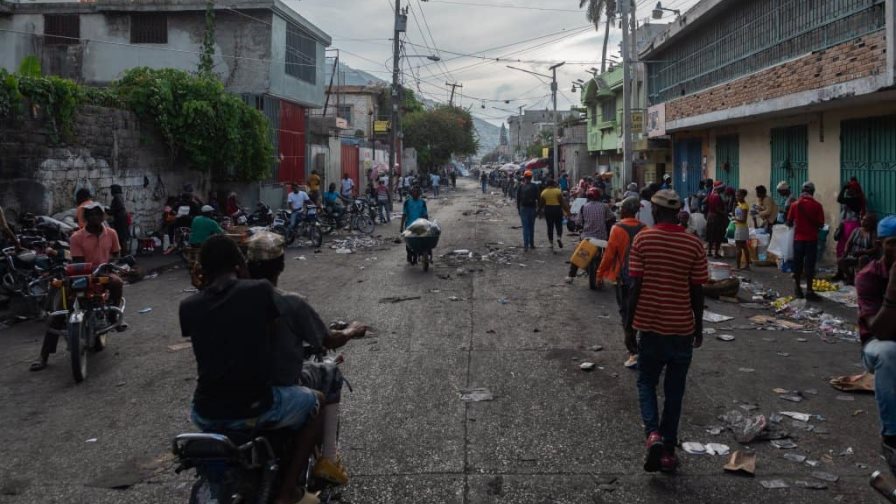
[629,224,709,336]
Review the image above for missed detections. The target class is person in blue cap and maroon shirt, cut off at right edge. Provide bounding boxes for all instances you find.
[856,215,896,475]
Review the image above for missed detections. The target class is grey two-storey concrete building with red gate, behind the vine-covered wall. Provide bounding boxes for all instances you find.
[0,0,331,195]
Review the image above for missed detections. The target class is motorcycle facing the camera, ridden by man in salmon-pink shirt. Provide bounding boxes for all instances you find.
[50,256,135,383]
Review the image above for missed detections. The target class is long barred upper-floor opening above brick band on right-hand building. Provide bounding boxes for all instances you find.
[648,0,886,103]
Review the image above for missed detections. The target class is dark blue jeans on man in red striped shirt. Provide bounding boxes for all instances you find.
[638,332,694,446]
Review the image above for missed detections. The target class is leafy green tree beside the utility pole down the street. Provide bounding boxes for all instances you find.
[402,105,479,171]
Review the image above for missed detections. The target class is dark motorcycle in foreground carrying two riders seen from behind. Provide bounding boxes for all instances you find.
[172,353,342,504]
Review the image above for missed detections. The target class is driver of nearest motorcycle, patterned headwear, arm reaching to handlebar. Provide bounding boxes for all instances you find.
[246,231,367,485]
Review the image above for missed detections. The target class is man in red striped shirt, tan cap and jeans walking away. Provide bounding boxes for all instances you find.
[626,189,708,472]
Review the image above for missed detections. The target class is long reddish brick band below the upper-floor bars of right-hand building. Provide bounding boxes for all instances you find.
[666,32,887,121]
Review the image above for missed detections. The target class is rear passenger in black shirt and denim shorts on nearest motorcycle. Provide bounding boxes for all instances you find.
[179,235,321,504]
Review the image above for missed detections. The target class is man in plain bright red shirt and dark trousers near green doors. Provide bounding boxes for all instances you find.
[787,182,824,301]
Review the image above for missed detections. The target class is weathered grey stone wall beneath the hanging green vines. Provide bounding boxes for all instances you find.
[0,107,209,230]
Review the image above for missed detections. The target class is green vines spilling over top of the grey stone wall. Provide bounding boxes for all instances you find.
[0,59,274,181]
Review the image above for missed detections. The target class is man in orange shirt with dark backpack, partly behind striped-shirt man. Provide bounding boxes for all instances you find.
[597,196,646,368]
